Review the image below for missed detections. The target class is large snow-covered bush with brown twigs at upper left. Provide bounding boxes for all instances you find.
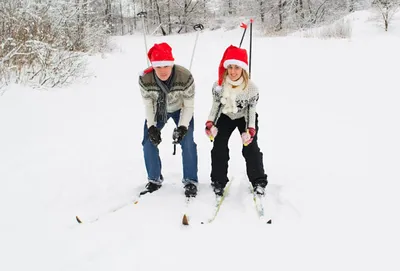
[0,0,109,88]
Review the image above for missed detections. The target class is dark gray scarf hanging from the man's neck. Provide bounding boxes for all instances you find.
[154,66,175,123]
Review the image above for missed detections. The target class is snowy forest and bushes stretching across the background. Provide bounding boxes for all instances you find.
[0,0,400,91]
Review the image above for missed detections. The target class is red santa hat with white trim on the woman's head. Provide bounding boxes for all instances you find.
[218,45,249,86]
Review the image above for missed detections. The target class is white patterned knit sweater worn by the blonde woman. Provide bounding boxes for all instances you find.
[208,78,259,128]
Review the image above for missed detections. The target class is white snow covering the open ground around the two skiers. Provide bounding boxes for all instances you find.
[0,12,400,271]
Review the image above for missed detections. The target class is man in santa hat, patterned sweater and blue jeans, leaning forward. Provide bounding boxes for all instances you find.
[139,43,198,197]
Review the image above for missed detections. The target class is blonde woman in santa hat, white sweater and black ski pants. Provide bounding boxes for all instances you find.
[206,45,268,196]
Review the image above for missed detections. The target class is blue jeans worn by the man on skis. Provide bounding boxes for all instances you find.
[142,110,198,184]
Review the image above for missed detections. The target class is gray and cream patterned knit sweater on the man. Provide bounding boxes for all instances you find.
[139,65,195,127]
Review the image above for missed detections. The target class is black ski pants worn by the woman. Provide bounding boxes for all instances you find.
[211,114,267,187]
